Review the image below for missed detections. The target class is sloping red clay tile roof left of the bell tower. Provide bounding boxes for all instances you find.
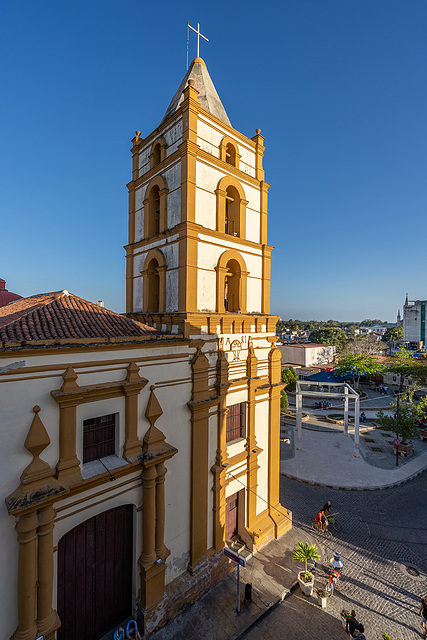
[0,291,159,342]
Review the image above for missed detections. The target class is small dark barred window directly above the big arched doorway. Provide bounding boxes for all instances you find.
[83,413,117,463]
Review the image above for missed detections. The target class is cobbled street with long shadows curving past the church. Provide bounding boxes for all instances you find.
[244,472,427,640]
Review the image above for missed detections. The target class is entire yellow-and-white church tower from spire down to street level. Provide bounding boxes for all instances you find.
[126,52,292,573]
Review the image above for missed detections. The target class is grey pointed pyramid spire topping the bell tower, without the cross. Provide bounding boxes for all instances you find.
[161,58,231,127]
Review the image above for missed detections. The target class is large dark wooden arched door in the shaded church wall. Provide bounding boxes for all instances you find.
[57,505,134,640]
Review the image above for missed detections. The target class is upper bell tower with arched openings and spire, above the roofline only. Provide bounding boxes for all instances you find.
[126,58,277,337]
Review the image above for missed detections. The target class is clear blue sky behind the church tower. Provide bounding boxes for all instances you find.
[0,0,427,321]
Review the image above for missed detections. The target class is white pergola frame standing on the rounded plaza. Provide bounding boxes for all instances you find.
[295,380,360,458]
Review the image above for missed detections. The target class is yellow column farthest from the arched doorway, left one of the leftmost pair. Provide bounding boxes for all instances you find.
[12,513,38,640]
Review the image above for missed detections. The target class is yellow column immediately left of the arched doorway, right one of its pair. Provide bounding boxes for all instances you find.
[37,506,60,640]
